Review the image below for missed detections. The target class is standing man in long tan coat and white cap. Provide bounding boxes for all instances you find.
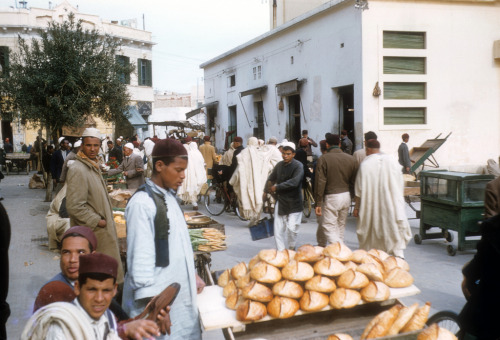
[66,128,123,284]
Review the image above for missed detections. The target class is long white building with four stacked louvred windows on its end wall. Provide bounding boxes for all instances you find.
[201,0,500,171]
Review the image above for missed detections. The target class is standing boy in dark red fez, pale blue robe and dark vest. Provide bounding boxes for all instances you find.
[123,139,205,340]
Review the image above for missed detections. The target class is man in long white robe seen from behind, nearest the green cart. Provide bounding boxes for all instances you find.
[353,139,412,258]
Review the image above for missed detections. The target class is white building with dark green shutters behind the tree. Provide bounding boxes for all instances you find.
[0,0,154,146]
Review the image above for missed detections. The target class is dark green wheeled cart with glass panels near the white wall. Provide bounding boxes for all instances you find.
[414,170,494,256]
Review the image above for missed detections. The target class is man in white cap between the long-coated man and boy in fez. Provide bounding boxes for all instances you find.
[108,143,144,189]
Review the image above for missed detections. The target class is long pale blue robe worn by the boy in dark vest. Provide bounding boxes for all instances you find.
[123,179,204,340]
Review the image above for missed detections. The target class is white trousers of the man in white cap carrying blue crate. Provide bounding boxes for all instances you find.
[274,202,302,250]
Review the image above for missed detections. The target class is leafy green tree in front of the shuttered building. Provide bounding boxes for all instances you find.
[0,13,134,140]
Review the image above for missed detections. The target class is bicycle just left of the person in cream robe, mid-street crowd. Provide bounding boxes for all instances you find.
[204,182,246,221]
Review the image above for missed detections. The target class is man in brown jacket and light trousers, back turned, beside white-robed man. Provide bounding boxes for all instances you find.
[314,134,357,247]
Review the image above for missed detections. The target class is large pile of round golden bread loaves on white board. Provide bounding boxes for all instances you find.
[218,242,413,321]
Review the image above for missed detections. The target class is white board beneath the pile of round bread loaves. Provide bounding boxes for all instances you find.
[198,285,420,331]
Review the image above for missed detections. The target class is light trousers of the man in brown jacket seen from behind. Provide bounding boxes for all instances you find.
[316,191,351,247]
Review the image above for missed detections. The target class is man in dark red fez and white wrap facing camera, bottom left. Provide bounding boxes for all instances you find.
[21,253,166,340]
